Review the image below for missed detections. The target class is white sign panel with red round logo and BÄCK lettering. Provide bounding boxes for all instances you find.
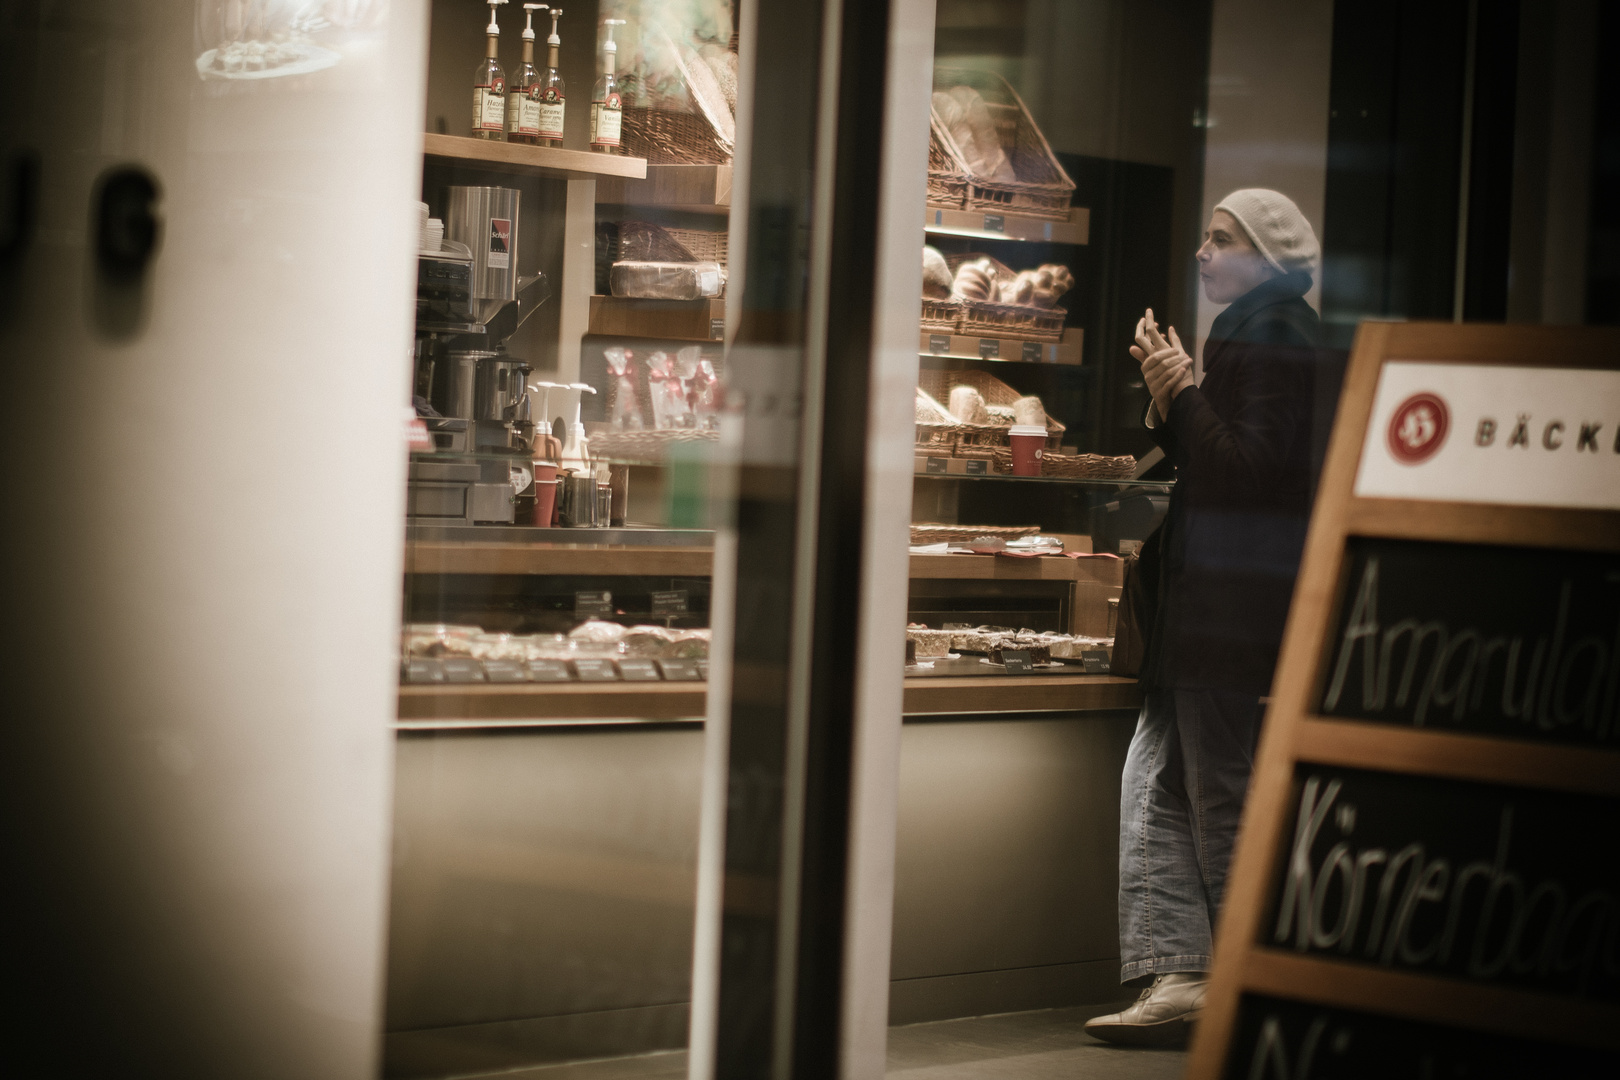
[1356,361,1620,510]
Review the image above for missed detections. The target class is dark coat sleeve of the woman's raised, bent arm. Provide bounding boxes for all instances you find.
[1155,334,1314,499]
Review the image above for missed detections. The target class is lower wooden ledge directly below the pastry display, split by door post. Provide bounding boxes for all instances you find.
[399,675,1142,725]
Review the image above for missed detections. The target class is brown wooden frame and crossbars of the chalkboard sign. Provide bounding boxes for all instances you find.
[1186,322,1620,1080]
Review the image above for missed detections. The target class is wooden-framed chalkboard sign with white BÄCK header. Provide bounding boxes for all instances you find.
[1187,322,1620,1080]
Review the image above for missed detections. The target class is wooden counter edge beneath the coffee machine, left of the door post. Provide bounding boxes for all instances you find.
[405,541,714,578]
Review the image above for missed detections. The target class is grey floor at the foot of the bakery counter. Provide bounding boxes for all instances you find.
[491,1007,1186,1080]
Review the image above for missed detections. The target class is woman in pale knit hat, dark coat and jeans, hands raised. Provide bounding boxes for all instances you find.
[1085,189,1320,1046]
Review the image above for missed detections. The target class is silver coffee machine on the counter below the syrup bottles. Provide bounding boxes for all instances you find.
[405,188,551,525]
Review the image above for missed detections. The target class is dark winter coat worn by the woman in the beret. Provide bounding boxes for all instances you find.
[1142,274,1320,696]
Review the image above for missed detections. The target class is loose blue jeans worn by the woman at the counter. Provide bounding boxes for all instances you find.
[1119,690,1260,983]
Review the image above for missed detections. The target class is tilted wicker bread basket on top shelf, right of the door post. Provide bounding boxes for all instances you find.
[926,68,1074,222]
